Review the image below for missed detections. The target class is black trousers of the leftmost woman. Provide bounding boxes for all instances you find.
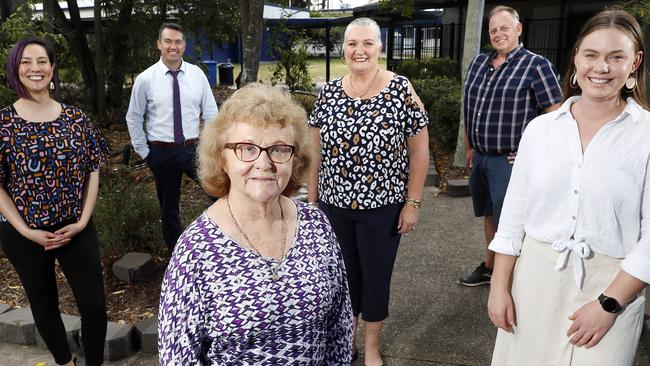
[0,220,106,365]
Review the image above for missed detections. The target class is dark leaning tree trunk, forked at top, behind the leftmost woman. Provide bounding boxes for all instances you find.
[43,0,97,112]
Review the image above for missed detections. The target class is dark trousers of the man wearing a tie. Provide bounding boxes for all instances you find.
[146,144,198,255]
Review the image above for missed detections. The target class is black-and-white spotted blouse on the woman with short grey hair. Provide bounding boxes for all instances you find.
[308,75,429,209]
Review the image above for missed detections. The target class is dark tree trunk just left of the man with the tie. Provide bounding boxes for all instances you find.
[108,0,133,111]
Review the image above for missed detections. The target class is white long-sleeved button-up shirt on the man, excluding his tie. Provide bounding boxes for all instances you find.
[126,59,217,159]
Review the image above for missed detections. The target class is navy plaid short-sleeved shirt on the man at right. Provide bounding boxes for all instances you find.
[463,43,562,154]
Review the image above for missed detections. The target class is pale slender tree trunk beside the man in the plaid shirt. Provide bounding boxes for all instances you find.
[454,0,485,167]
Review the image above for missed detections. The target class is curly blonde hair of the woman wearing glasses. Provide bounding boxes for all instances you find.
[197,83,312,197]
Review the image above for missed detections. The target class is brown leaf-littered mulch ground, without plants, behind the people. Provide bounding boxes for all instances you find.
[0,85,467,324]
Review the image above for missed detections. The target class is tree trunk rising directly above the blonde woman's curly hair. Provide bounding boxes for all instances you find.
[239,0,264,87]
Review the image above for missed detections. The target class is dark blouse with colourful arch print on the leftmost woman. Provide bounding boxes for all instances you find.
[0,104,110,228]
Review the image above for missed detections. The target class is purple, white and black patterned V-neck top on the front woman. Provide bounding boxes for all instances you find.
[158,202,353,366]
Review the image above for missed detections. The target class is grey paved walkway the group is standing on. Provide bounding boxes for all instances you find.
[0,191,650,366]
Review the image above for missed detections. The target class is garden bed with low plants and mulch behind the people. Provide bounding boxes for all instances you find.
[0,89,467,323]
